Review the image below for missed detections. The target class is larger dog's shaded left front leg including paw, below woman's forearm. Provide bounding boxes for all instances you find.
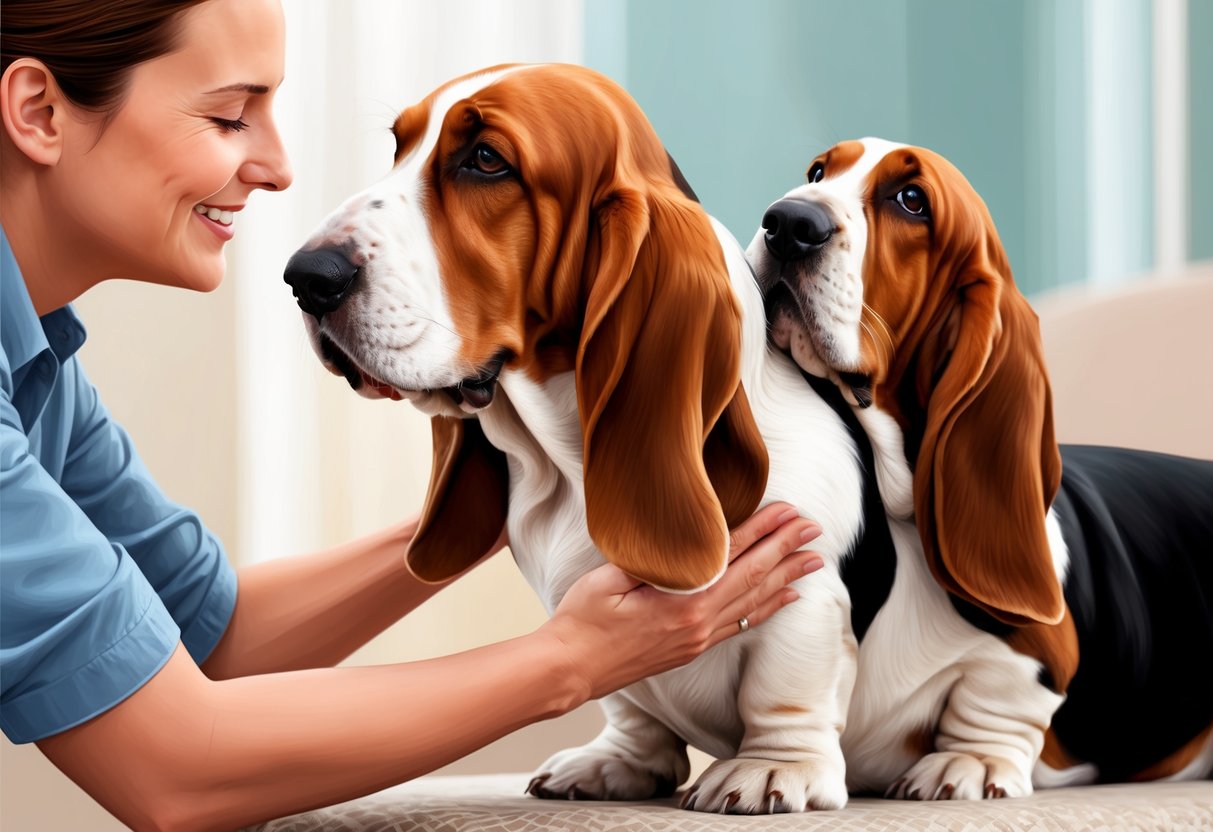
[526,694,690,800]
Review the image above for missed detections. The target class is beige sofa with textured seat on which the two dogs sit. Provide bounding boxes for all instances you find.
[257,269,1213,832]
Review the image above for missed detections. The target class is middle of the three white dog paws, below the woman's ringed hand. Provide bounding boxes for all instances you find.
[682,757,847,815]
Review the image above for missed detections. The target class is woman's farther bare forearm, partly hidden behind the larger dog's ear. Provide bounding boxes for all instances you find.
[203,518,505,679]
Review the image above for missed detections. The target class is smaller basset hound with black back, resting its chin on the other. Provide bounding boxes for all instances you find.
[747,138,1213,799]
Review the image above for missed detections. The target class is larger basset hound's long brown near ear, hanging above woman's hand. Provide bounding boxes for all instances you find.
[576,188,768,592]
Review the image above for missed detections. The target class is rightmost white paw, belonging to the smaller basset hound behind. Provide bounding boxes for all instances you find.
[884,751,1032,800]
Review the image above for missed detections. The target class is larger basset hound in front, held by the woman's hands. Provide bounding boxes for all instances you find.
[285,65,902,813]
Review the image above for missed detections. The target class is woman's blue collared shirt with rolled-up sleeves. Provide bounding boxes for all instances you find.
[0,229,237,742]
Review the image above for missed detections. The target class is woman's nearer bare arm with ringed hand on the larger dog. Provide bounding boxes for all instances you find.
[38,507,821,830]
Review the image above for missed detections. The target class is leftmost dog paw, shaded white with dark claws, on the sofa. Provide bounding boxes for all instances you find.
[526,746,690,800]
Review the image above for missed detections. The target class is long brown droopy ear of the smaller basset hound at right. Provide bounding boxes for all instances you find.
[913,240,1065,625]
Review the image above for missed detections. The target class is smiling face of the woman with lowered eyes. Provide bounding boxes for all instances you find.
[56,0,291,291]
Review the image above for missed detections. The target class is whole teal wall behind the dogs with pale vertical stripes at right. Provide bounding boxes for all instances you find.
[586,0,1193,294]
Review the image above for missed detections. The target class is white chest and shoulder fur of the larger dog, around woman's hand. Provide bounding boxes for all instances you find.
[480,357,883,757]
